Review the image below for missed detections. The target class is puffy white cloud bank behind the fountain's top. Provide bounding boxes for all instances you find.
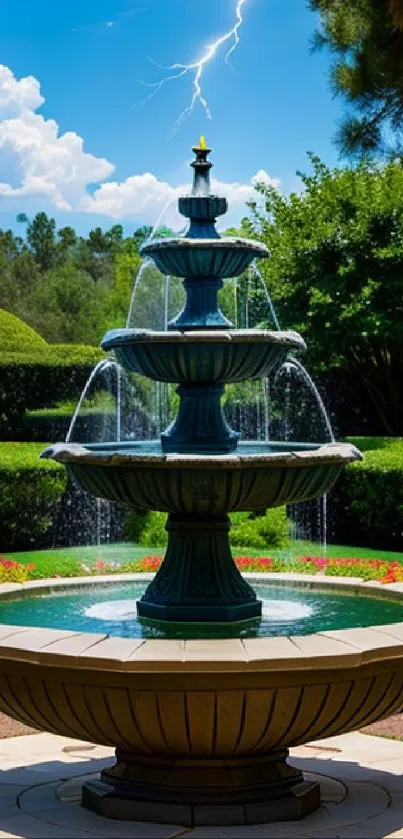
[0,65,278,227]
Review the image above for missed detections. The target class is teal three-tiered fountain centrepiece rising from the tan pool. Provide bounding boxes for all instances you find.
[43,142,361,623]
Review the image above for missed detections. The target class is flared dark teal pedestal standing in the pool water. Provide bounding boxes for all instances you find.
[137,514,262,623]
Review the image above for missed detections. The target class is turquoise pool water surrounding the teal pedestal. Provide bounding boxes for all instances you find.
[0,582,403,638]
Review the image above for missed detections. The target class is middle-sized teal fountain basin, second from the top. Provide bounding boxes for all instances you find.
[101,329,306,385]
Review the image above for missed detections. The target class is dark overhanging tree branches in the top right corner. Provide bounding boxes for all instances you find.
[308,0,403,154]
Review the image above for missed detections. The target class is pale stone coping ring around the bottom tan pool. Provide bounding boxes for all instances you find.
[0,574,403,675]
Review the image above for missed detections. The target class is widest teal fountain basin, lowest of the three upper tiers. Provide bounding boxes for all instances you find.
[42,441,362,516]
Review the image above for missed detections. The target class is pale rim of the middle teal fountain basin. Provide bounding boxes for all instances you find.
[102,329,306,350]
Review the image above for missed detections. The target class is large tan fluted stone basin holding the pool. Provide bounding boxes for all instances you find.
[0,574,403,756]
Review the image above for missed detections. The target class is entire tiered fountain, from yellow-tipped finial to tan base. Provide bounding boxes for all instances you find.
[0,139,403,826]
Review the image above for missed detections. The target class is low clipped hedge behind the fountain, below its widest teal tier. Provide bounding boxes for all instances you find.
[0,437,403,553]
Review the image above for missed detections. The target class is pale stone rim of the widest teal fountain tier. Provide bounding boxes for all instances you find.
[42,443,362,470]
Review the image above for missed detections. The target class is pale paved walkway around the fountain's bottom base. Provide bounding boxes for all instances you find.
[0,733,403,839]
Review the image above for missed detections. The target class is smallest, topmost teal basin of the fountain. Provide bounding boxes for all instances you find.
[140,236,269,279]
